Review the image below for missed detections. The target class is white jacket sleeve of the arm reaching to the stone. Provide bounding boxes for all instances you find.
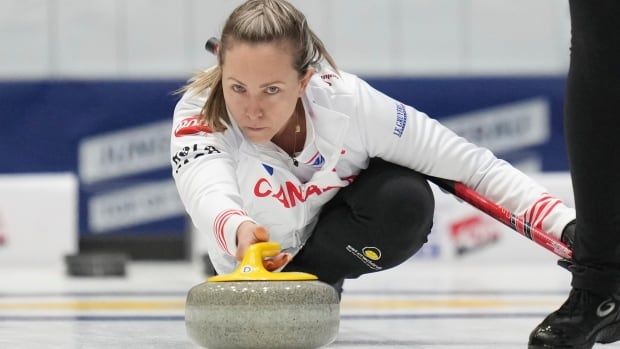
[170,90,253,273]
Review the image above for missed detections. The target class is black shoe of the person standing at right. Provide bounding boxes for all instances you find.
[528,288,620,349]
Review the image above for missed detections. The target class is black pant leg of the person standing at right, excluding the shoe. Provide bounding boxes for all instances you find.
[565,0,620,294]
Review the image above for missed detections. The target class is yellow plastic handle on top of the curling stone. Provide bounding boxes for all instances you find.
[207,242,318,282]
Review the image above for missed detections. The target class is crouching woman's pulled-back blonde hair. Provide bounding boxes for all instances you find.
[180,0,338,131]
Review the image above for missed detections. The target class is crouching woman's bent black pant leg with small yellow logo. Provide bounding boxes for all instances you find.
[284,159,435,284]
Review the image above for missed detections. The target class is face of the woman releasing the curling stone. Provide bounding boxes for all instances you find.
[222,42,312,143]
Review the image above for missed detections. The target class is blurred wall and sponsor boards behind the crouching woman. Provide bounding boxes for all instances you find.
[0,0,572,265]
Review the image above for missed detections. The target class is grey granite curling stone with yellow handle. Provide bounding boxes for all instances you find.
[185,242,340,349]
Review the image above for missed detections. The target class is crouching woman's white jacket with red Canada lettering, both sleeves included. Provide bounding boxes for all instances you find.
[171,66,575,273]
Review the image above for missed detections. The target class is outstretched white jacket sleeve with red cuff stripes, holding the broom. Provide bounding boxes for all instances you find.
[356,79,575,238]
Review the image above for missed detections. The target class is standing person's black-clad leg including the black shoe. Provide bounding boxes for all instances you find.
[530,0,620,348]
